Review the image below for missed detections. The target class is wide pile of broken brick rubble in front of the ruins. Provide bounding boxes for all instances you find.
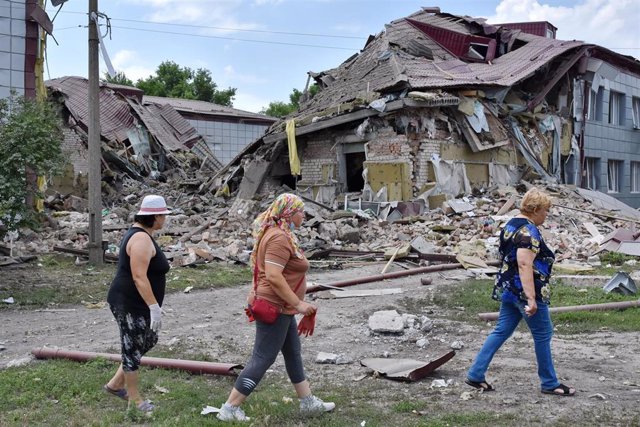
[0,181,640,266]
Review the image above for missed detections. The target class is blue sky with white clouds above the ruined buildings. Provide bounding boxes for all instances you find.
[45,0,640,112]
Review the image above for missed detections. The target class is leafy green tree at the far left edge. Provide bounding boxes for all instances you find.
[0,96,64,235]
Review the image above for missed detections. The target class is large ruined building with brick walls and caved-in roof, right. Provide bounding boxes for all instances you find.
[224,8,640,207]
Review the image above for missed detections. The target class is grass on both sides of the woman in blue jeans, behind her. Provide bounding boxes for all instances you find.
[433,280,640,334]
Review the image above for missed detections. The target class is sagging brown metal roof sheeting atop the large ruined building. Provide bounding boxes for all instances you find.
[300,10,592,114]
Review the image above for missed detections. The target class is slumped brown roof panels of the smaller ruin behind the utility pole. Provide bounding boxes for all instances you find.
[45,77,222,183]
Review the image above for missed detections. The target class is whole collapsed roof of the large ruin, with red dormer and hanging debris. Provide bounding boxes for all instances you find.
[217,8,640,202]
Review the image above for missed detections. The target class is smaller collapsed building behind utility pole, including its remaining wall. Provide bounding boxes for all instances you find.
[45,77,223,200]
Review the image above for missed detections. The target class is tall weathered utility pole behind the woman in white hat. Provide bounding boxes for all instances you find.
[88,0,104,265]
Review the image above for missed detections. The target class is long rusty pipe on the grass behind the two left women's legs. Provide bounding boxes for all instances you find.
[31,347,242,376]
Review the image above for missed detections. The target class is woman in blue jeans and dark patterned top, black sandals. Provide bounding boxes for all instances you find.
[465,188,576,396]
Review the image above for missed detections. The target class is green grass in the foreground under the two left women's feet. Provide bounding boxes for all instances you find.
[0,359,480,427]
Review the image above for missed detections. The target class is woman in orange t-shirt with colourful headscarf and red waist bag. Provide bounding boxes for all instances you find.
[217,193,335,421]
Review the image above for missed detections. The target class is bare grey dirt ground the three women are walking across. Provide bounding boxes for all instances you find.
[0,265,640,425]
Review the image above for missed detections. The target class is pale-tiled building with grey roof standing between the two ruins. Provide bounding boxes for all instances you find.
[143,95,278,164]
